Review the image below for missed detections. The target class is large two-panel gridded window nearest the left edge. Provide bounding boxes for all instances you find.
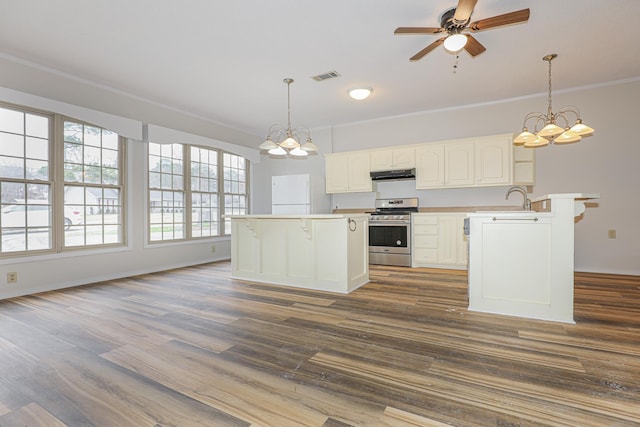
[0,106,124,254]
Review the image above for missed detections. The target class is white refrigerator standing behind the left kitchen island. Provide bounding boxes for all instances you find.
[271,174,331,215]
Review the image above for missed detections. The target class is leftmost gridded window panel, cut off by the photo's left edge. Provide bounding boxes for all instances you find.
[0,108,53,253]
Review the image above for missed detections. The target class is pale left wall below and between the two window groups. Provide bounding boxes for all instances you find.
[0,140,231,299]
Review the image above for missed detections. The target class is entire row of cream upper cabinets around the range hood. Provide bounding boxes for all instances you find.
[326,134,535,193]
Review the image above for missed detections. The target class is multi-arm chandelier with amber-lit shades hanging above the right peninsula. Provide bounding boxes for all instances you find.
[513,53,595,148]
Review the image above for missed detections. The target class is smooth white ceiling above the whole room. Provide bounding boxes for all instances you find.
[0,0,640,142]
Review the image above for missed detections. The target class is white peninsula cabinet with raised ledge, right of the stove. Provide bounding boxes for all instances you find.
[468,193,599,323]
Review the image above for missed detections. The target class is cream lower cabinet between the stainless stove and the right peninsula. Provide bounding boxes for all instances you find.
[411,212,467,270]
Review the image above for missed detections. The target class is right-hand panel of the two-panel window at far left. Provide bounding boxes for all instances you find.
[64,120,123,247]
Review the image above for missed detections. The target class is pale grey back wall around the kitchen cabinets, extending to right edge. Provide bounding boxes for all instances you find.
[254,80,640,275]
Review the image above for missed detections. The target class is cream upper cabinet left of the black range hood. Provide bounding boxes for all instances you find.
[325,151,373,193]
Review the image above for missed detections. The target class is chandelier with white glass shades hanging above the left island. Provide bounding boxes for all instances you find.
[258,78,318,157]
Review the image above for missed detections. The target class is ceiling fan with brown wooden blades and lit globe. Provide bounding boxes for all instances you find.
[393,0,529,61]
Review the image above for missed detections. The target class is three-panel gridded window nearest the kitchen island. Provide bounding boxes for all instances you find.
[148,142,248,242]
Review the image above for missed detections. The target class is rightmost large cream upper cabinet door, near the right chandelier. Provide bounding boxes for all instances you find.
[475,137,511,185]
